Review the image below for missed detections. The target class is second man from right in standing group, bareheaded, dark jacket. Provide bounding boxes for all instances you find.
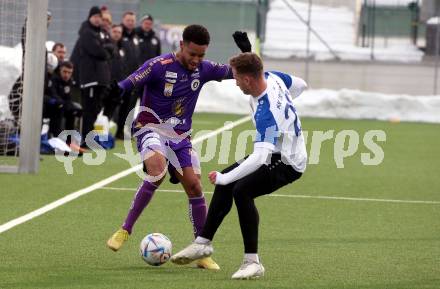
[116,11,142,139]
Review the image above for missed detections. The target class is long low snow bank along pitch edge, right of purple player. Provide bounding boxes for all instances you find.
[196,80,440,123]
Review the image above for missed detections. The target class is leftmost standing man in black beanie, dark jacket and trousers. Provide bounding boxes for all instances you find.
[77,6,113,148]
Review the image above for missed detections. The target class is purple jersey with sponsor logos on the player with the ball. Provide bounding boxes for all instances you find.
[119,53,232,132]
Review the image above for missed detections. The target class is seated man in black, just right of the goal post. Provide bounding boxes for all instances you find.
[43,61,82,137]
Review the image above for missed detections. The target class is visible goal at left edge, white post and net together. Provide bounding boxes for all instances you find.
[0,0,48,173]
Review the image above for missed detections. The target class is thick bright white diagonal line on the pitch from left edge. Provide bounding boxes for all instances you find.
[0,116,251,234]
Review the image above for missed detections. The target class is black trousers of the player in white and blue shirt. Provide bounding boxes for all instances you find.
[200,154,302,253]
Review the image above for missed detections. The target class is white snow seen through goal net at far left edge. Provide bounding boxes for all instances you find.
[0,45,22,121]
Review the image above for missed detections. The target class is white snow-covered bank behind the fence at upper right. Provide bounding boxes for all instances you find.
[263,0,423,62]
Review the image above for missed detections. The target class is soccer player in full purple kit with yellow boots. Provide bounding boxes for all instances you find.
[107,25,251,270]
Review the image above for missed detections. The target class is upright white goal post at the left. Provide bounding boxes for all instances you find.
[18,0,48,173]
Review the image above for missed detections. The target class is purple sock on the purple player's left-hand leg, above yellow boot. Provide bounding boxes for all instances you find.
[122,181,157,234]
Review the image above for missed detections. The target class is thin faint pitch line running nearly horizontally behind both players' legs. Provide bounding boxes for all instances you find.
[100,187,440,204]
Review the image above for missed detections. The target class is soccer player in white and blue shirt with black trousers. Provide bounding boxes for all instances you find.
[171,53,307,279]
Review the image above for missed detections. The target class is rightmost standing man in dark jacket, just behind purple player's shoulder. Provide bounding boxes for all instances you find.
[136,14,161,65]
